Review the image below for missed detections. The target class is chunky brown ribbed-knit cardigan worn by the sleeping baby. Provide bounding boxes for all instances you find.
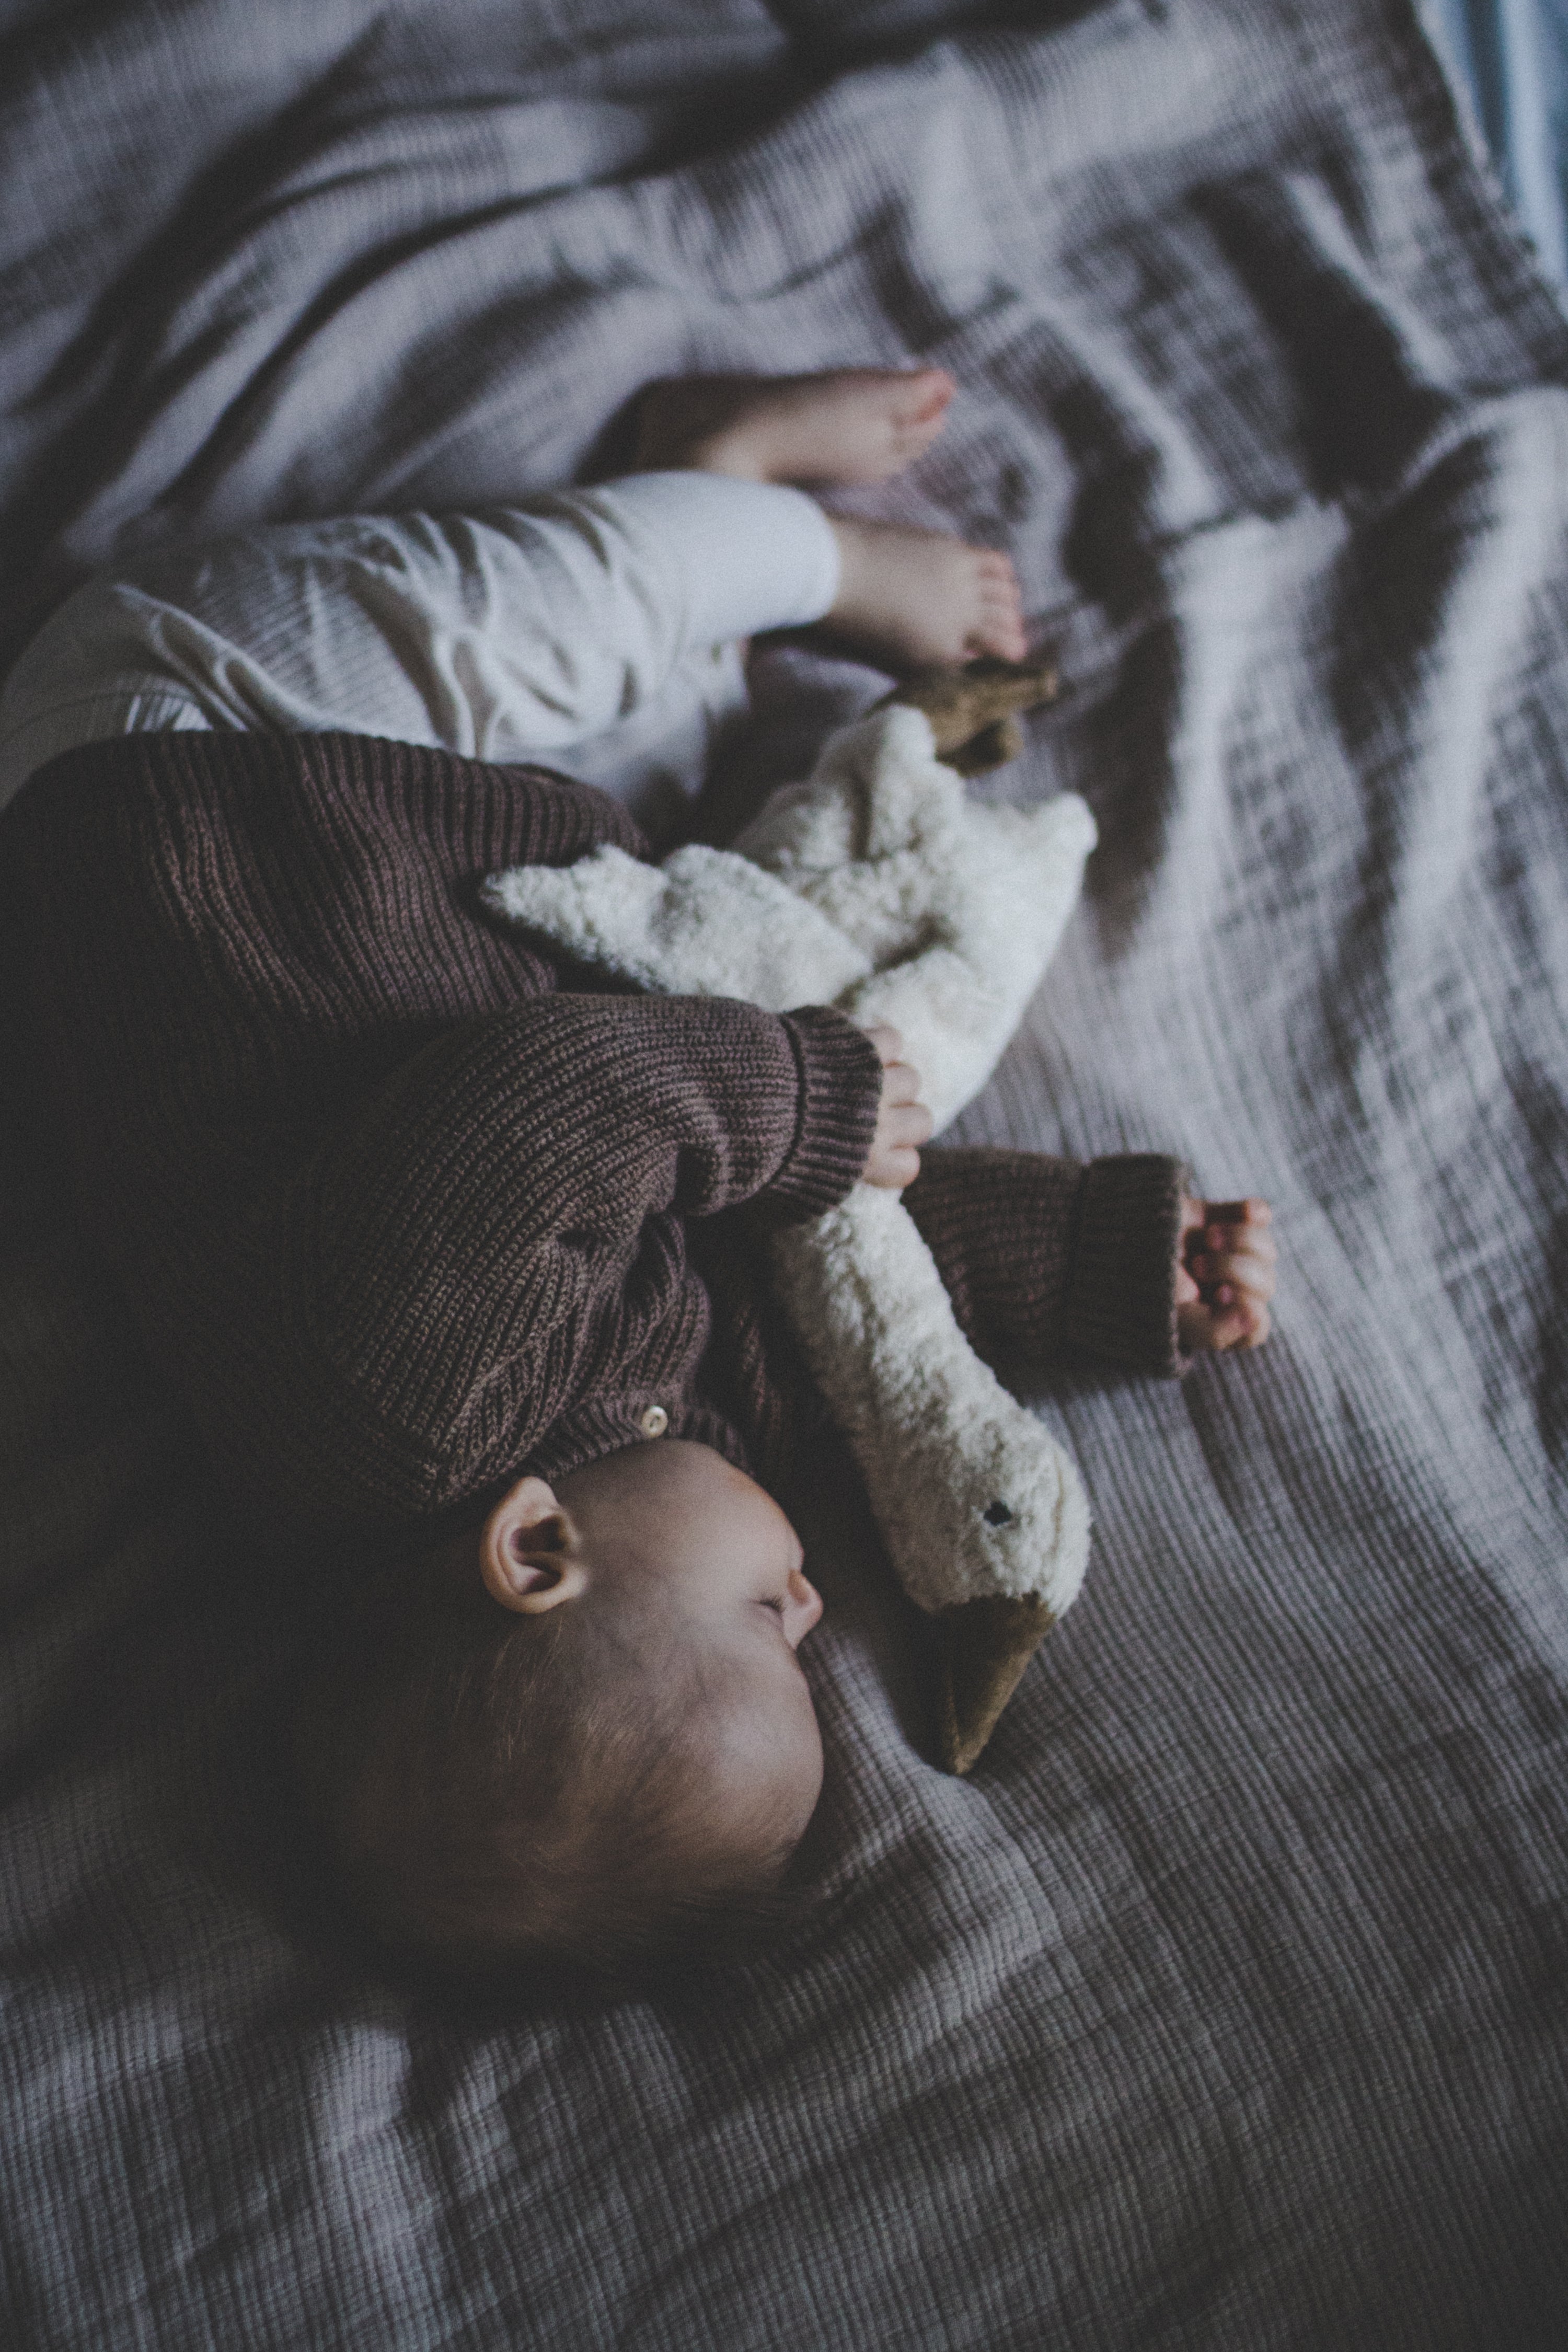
[0,734,1180,1531]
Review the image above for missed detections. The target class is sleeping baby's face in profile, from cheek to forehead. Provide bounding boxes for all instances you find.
[557,1439,823,1844]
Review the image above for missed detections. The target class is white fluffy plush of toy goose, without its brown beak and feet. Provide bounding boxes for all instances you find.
[487,706,1096,1616]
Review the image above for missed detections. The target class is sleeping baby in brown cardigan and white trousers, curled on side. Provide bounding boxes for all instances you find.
[0,370,1274,1969]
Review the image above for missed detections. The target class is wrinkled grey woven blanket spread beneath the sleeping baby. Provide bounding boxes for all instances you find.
[0,0,1568,2352]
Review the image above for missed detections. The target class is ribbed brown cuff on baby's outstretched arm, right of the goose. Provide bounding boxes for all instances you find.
[1063,1152,1187,1374]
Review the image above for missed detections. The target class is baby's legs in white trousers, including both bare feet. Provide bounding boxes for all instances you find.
[0,370,1023,804]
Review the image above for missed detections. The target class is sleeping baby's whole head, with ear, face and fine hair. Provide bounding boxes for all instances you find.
[296,1439,823,1974]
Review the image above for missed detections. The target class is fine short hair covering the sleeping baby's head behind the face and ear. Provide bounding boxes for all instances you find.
[292,1560,809,1983]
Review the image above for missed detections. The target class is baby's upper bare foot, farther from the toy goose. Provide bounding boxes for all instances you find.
[635,367,954,489]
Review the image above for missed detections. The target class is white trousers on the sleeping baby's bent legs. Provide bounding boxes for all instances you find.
[0,473,839,807]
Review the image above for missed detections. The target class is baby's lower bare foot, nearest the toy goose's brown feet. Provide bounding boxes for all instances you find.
[827,515,1028,668]
